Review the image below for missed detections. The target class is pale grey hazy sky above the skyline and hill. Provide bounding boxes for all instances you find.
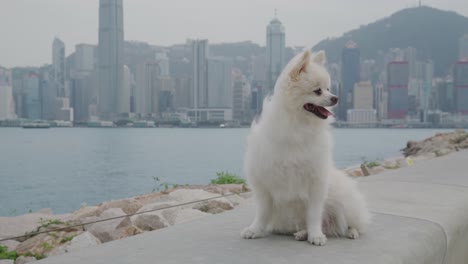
[0,0,468,67]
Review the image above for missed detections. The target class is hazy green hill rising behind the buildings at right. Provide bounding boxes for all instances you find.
[313,6,468,76]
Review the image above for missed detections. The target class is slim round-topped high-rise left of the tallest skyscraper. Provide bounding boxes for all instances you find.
[52,38,67,97]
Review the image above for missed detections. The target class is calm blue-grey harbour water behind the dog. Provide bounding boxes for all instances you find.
[0,128,454,216]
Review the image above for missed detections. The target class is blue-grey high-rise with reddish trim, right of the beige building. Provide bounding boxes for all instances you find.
[387,61,409,119]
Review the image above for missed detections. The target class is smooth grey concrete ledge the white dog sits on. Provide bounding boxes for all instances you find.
[38,151,468,264]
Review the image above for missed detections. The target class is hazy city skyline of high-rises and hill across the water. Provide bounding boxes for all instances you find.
[2,0,468,126]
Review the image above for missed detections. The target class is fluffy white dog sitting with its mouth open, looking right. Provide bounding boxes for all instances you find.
[241,51,370,246]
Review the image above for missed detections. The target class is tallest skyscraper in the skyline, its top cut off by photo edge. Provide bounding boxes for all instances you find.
[98,0,124,120]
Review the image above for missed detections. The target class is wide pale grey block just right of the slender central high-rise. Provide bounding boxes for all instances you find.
[208,57,232,108]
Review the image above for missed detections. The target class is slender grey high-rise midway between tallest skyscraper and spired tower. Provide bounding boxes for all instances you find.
[192,39,209,109]
